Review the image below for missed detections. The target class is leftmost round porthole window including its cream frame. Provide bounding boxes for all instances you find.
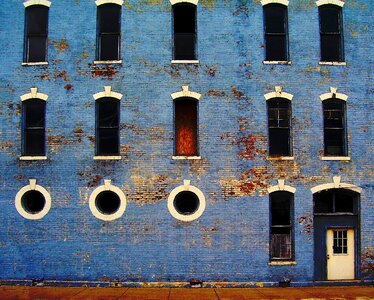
[15,179,51,220]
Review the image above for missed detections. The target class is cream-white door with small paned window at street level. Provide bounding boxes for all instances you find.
[326,229,355,280]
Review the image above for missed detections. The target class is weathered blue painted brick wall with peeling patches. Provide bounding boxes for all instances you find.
[0,0,374,282]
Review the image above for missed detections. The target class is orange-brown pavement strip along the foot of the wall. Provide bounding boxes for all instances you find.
[0,286,374,300]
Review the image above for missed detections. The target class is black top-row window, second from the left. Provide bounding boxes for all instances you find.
[97,4,121,61]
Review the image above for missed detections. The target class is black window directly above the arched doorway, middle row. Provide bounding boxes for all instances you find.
[323,99,347,156]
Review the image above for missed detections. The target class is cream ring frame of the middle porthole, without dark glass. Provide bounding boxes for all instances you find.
[89,179,127,221]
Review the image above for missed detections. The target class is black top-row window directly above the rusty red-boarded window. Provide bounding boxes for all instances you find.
[173,3,197,60]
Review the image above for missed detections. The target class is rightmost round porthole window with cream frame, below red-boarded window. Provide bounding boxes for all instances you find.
[168,180,205,222]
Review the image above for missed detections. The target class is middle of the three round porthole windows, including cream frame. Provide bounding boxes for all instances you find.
[89,180,126,221]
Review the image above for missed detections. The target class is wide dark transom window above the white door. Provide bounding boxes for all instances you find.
[314,189,357,214]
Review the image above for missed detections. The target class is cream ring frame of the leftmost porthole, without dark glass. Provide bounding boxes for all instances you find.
[15,179,52,220]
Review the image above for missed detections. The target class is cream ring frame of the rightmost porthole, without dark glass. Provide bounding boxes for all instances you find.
[168,180,206,222]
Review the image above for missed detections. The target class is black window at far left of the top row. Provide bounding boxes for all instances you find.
[23,5,49,63]
